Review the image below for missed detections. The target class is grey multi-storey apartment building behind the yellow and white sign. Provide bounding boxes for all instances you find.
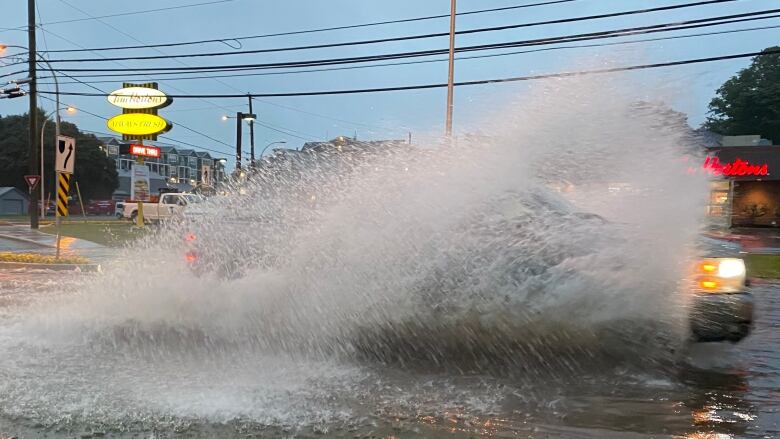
[99,137,227,200]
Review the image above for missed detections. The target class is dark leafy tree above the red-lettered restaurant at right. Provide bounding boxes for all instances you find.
[704,46,780,143]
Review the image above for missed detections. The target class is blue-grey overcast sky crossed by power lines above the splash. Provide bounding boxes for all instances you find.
[0,0,780,162]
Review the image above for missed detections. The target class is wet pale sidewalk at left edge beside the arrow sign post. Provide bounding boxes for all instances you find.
[0,223,115,262]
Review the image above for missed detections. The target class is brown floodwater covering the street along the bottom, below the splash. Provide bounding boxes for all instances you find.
[0,274,780,439]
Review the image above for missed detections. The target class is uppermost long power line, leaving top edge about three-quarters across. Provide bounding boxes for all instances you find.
[39,0,578,53]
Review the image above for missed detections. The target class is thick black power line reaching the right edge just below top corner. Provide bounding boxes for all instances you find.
[38,9,780,77]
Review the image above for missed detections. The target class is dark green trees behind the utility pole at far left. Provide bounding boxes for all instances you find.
[0,110,119,200]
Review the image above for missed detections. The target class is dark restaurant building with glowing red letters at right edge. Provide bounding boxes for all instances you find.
[702,135,780,227]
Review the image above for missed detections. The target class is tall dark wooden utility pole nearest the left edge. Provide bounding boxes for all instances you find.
[27,0,40,229]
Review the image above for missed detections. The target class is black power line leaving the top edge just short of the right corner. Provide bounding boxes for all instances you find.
[42,0,736,63]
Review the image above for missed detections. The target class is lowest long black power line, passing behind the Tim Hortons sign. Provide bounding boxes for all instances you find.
[38,49,780,99]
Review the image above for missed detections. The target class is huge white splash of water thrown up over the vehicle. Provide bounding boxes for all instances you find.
[0,75,706,434]
